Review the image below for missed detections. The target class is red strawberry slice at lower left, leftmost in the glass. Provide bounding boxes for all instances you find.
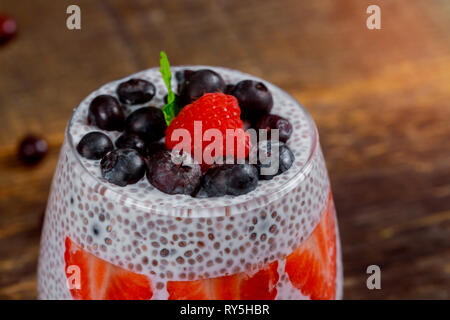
[64,237,153,300]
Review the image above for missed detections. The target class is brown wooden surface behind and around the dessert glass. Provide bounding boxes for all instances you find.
[0,0,450,299]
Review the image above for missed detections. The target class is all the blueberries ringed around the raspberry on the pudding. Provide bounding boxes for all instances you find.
[77,69,294,197]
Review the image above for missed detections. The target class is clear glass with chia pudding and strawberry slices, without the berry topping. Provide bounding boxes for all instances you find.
[38,66,342,300]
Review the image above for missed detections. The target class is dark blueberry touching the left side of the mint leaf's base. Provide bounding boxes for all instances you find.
[125,107,166,143]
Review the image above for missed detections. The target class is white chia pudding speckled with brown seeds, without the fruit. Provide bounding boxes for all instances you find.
[38,66,342,299]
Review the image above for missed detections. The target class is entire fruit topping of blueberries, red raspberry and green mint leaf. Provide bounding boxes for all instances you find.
[77,51,294,192]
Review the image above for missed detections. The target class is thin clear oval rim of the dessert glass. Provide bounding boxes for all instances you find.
[65,65,319,218]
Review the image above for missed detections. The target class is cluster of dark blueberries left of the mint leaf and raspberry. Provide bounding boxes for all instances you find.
[77,79,166,186]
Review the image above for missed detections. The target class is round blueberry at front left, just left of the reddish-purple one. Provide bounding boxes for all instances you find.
[100,149,145,187]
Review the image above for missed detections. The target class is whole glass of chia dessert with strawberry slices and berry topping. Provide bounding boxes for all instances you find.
[38,55,342,300]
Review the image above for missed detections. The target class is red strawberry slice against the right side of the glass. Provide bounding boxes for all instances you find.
[285,194,336,300]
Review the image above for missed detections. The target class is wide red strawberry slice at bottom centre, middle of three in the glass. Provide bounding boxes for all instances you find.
[167,261,279,300]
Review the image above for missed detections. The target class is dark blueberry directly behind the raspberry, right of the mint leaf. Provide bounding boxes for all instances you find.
[180,69,225,105]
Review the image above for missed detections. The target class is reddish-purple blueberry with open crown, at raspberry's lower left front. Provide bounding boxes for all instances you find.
[147,150,202,194]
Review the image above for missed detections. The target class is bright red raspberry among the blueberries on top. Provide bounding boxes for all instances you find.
[166,93,250,164]
